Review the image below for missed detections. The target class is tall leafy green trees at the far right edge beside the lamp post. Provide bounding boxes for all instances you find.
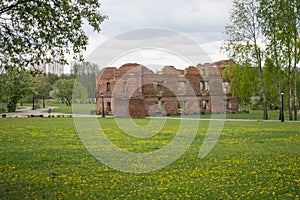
[259,0,300,120]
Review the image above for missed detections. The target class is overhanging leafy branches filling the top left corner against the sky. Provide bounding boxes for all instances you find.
[0,0,106,72]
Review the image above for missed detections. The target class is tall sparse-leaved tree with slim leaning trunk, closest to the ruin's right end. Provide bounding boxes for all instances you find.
[222,0,268,119]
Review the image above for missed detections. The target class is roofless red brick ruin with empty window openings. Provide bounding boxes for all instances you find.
[96,60,238,117]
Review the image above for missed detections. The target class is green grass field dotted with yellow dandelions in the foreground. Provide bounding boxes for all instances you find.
[0,118,300,199]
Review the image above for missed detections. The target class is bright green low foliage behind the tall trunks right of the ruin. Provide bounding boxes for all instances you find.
[222,60,300,111]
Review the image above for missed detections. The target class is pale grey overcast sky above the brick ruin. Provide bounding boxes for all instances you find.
[85,0,232,67]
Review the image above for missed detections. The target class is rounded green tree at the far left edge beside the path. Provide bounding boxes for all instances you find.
[0,70,37,112]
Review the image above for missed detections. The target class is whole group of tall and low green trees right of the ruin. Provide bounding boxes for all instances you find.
[222,0,300,120]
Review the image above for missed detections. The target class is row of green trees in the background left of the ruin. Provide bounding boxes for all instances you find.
[0,62,98,112]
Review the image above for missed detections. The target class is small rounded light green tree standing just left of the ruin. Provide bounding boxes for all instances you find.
[53,79,87,106]
